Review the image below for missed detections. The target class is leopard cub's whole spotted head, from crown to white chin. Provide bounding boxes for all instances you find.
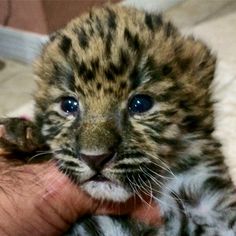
[35,6,214,201]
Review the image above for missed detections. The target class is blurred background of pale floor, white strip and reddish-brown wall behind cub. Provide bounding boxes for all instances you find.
[0,0,236,181]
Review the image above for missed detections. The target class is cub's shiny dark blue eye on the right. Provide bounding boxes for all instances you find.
[129,94,153,113]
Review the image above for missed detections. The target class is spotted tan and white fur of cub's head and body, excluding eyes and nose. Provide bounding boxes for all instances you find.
[35,5,236,236]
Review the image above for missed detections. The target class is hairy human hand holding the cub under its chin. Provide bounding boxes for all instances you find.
[0,156,159,236]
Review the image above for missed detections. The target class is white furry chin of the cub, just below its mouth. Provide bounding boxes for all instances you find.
[81,181,133,202]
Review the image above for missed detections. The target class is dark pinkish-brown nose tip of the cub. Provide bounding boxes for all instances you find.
[80,152,116,171]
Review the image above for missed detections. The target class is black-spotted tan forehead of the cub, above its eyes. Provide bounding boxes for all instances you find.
[38,6,179,98]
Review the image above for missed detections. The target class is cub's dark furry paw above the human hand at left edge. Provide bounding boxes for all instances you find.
[0,118,45,153]
